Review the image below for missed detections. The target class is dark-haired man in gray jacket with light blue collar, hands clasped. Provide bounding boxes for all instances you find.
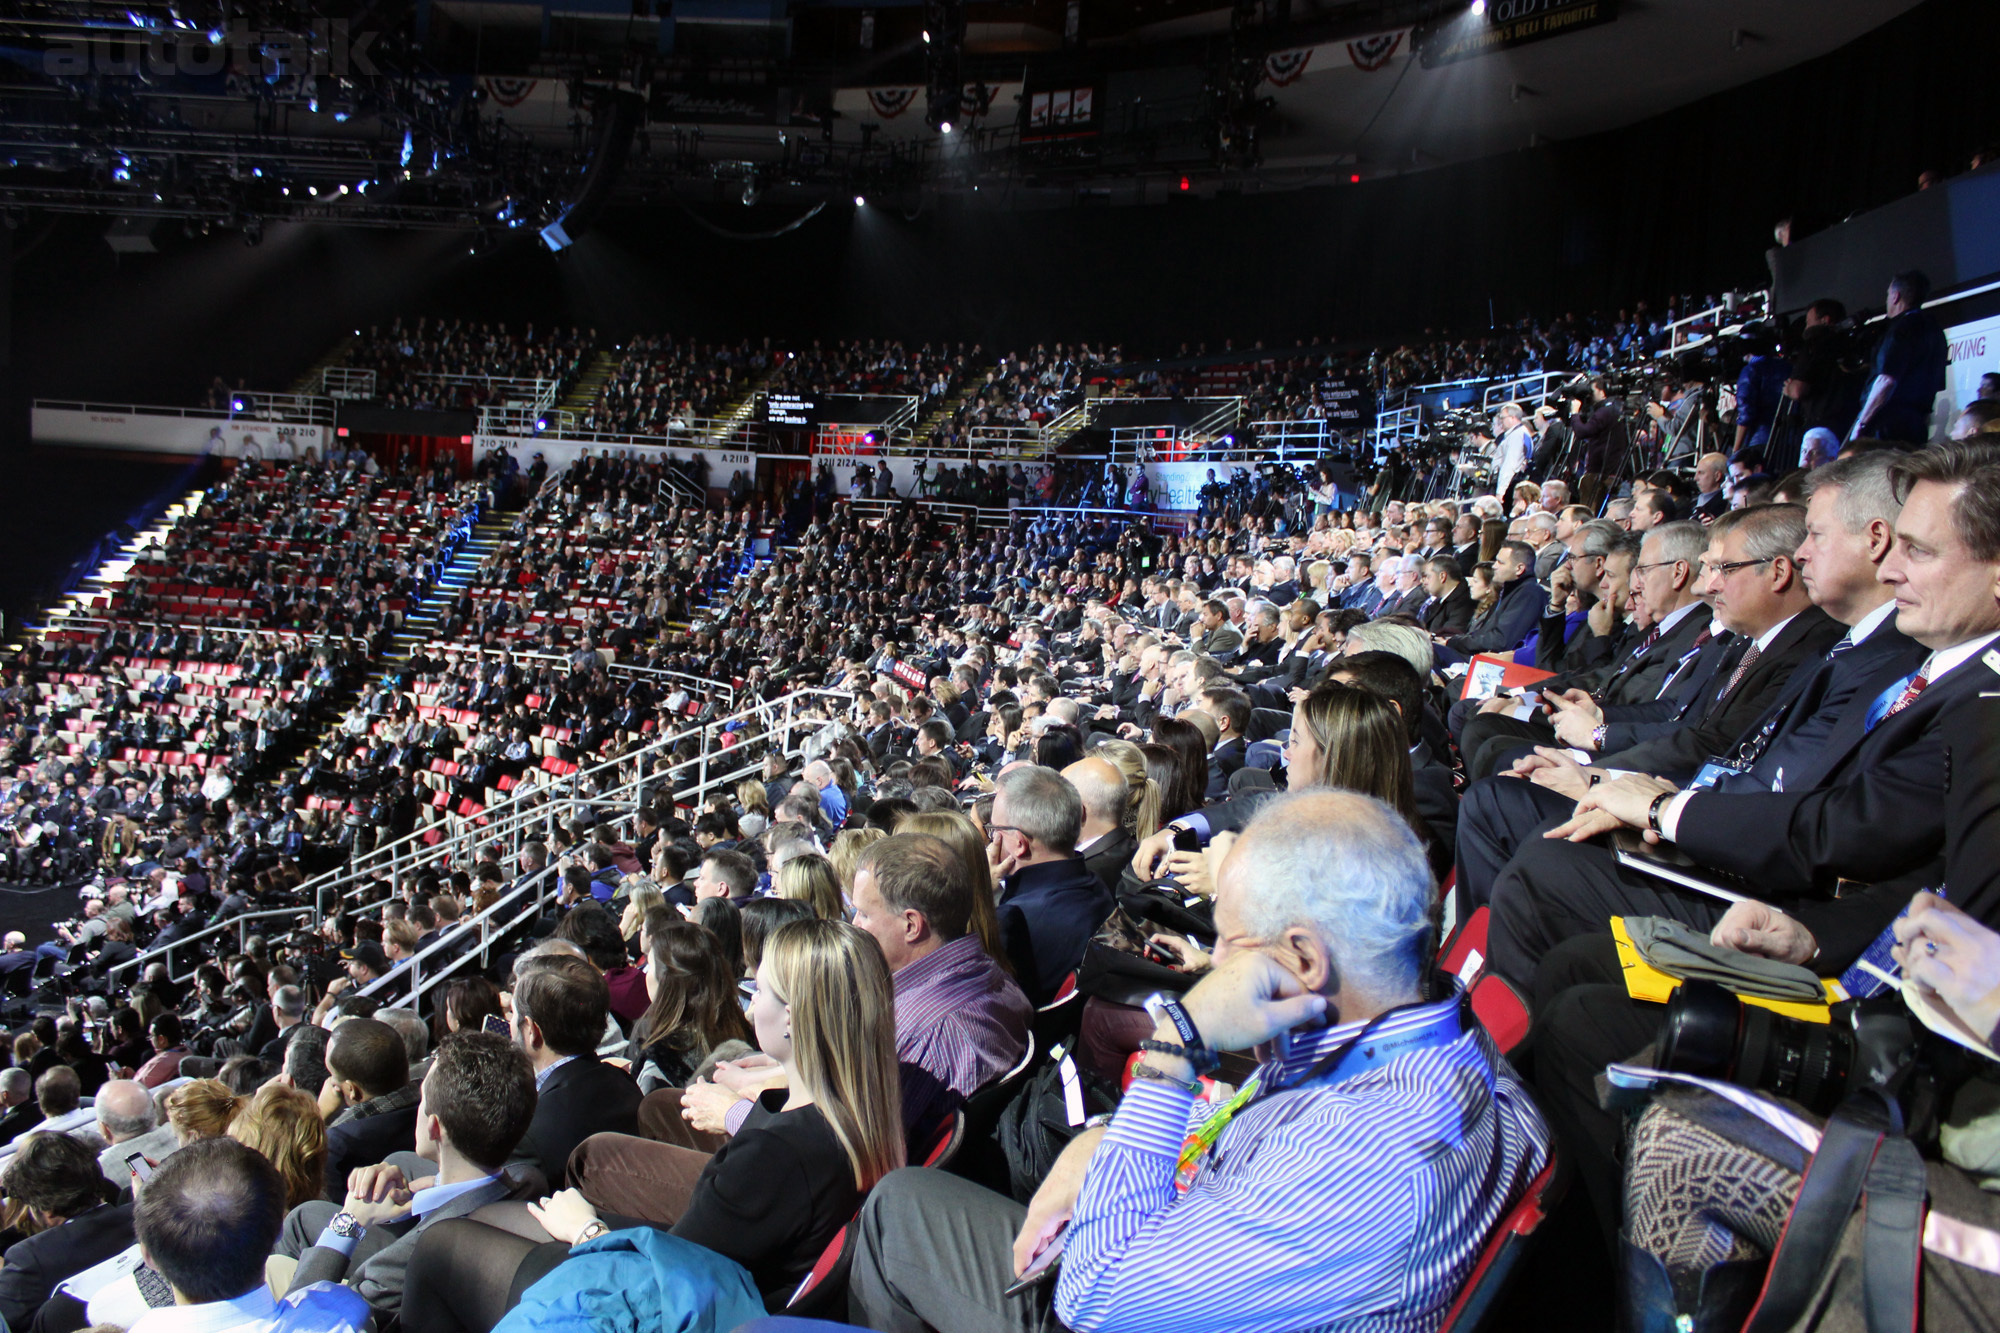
[276,1020,536,1319]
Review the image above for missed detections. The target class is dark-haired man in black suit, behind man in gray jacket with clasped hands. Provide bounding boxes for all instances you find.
[506,953,640,1189]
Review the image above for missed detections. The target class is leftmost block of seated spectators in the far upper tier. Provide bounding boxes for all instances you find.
[346,318,598,408]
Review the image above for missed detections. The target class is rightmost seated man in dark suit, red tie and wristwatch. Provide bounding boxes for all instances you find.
[1490,444,2000,991]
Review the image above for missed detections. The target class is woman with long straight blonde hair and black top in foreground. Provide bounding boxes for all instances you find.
[520,919,904,1301]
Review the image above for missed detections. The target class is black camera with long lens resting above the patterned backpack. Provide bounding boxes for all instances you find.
[1656,981,1918,1115]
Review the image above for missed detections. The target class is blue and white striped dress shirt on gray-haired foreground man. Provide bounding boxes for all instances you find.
[1056,1001,1548,1333]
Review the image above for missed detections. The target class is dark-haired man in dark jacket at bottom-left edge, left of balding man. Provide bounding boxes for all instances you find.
[0,1135,132,1329]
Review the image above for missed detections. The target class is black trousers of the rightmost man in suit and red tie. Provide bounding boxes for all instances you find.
[1496,836,1728,995]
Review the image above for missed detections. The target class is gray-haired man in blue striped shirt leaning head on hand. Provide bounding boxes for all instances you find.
[848,791,1550,1333]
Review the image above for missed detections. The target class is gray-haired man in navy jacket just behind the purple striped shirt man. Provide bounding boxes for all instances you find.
[986,765,1112,1005]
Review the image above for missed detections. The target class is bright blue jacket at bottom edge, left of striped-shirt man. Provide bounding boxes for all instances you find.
[494,1227,764,1333]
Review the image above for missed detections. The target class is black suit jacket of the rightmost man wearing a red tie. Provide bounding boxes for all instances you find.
[1676,640,2000,960]
